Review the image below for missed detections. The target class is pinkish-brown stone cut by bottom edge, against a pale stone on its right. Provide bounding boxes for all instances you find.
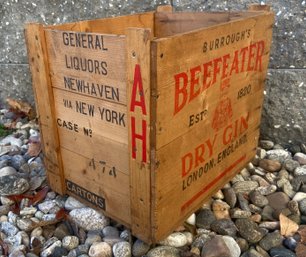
[201,236,231,257]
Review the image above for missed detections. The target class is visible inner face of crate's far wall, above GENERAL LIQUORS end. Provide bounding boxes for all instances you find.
[48,12,154,35]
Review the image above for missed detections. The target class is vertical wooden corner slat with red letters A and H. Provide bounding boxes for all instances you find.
[127,28,152,241]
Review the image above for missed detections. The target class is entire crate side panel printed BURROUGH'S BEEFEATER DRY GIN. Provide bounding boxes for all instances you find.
[155,14,273,237]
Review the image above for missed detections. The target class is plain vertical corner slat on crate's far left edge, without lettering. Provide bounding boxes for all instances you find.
[25,23,65,194]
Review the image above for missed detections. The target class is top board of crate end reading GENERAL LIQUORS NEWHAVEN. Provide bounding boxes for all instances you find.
[46,30,126,105]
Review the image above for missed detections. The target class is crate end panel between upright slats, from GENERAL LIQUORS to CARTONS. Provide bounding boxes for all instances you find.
[45,30,130,224]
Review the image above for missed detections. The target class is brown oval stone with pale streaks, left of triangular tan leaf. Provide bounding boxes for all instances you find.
[235,218,264,244]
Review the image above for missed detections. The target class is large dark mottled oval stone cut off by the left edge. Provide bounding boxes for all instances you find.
[0,175,30,195]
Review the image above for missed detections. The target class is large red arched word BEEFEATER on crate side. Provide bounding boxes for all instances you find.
[174,41,265,115]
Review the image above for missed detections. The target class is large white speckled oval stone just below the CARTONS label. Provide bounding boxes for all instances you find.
[69,208,109,231]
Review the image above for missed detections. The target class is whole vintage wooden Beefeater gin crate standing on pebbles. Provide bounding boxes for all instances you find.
[25,5,274,242]
